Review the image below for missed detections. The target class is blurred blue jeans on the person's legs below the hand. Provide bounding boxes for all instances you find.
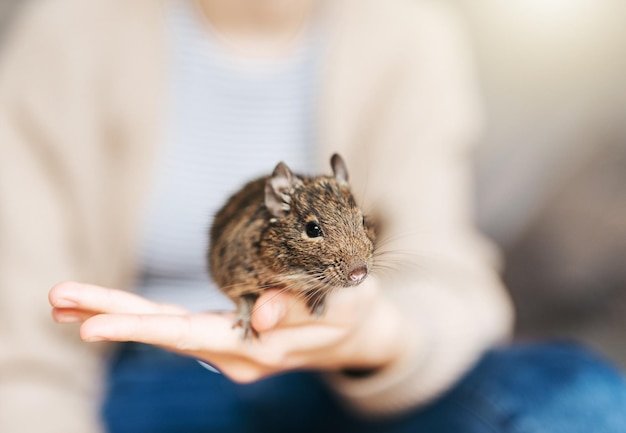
[103,343,626,433]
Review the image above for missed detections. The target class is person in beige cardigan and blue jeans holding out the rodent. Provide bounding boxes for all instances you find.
[0,0,626,433]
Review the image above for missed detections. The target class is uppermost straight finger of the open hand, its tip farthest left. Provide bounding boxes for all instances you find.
[48,281,187,314]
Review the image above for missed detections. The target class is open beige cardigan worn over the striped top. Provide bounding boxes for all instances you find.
[0,0,511,433]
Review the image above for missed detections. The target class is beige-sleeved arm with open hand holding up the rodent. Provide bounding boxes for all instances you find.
[50,0,510,422]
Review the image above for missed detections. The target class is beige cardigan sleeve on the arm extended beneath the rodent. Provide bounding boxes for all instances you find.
[326,2,512,415]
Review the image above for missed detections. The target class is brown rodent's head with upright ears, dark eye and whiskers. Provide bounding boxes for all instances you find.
[260,154,374,291]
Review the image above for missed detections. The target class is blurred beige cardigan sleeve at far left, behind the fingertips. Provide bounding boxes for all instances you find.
[0,1,108,433]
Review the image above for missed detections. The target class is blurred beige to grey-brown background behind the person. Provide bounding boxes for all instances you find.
[0,0,626,366]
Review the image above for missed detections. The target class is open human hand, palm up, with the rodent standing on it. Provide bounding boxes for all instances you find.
[49,278,403,382]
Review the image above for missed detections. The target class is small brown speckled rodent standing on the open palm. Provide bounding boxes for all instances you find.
[207,154,375,340]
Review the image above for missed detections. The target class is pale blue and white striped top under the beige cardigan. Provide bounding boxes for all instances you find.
[139,0,321,311]
